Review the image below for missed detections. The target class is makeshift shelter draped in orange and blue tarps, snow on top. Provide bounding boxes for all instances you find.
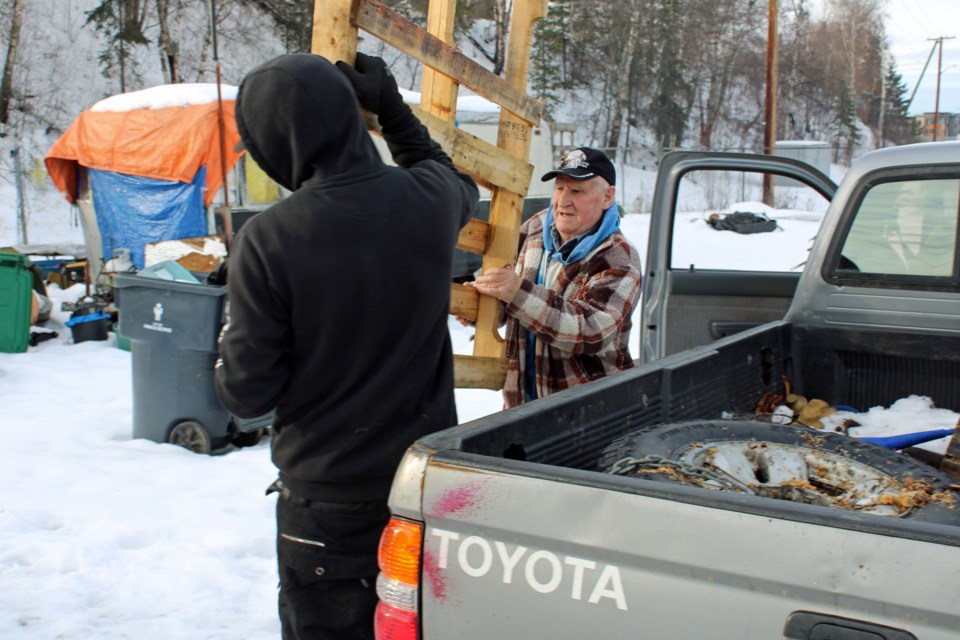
[45,84,243,279]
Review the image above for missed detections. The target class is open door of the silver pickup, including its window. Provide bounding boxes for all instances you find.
[639,151,837,362]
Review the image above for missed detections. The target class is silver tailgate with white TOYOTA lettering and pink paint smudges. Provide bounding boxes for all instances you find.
[420,454,960,640]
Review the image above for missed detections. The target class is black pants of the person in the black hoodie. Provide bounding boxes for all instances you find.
[277,484,390,640]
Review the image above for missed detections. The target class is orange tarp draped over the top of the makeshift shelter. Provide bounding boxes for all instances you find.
[44,100,243,206]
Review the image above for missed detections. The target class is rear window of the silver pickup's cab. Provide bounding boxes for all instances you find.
[838,179,960,277]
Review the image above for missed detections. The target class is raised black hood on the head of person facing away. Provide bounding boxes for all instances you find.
[236,53,383,191]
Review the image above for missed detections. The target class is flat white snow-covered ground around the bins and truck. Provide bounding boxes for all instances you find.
[0,162,958,640]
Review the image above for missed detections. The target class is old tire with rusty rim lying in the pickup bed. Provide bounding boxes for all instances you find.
[600,420,960,525]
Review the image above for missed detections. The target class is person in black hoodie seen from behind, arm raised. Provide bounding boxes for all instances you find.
[215,54,478,640]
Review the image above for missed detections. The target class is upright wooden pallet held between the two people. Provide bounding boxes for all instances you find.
[311,0,547,389]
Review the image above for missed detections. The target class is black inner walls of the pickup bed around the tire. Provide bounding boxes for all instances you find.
[432,322,960,470]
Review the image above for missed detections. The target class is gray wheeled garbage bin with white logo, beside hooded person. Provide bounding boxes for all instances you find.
[113,274,270,453]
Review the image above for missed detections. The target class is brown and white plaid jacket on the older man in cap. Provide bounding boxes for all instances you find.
[503,211,642,408]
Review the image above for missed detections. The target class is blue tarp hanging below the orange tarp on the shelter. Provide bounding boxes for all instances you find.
[89,166,207,269]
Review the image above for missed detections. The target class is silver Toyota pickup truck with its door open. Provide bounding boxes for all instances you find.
[376,142,960,640]
